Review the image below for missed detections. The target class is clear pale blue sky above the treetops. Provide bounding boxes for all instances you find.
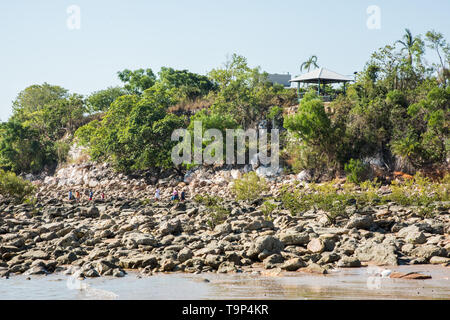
[0,0,450,121]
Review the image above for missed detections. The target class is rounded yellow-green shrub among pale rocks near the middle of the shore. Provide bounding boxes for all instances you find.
[232,171,269,201]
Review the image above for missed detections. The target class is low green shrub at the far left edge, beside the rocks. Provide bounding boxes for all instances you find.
[0,170,34,203]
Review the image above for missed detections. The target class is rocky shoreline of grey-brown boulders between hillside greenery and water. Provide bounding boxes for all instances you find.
[0,165,450,277]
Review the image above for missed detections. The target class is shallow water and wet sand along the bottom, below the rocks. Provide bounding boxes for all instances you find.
[0,265,450,300]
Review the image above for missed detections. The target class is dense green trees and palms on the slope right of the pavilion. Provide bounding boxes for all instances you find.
[284,30,450,179]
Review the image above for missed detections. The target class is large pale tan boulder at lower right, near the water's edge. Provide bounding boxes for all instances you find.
[355,242,398,266]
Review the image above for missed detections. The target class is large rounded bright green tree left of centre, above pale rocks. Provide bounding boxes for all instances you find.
[76,87,184,172]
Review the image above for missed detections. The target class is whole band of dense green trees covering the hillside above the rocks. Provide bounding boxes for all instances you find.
[0,30,450,184]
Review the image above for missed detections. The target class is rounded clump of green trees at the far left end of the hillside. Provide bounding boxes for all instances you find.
[0,83,86,173]
